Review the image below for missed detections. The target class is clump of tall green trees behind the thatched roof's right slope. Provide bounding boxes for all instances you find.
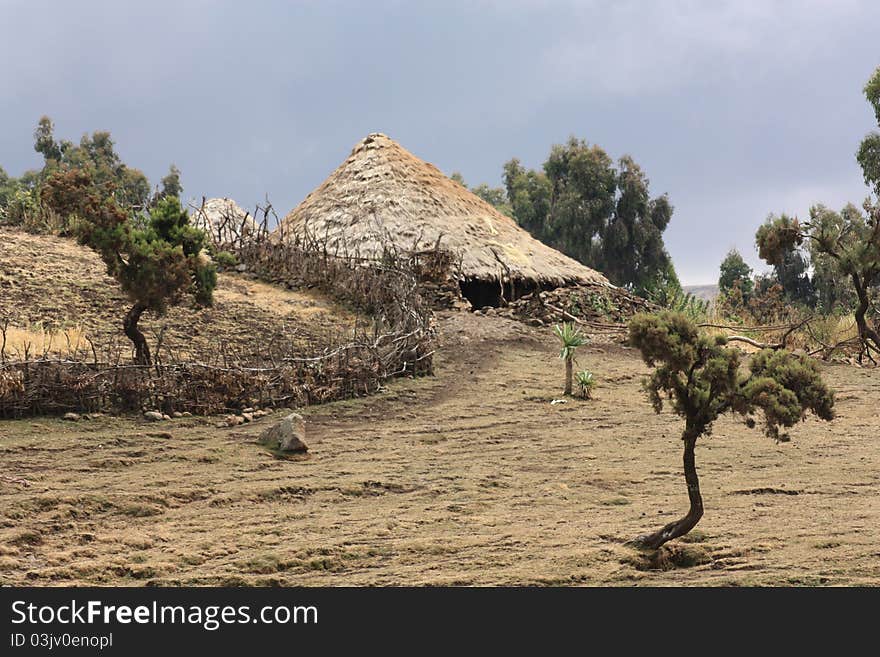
[504,137,673,295]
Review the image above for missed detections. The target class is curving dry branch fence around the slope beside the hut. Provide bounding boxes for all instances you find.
[0,206,443,418]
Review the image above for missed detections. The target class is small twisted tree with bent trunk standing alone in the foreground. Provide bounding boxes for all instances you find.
[629,312,834,549]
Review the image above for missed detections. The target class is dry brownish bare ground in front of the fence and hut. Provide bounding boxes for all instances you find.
[0,313,880,585]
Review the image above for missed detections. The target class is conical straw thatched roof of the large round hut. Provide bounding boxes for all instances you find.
[275,133,608,285]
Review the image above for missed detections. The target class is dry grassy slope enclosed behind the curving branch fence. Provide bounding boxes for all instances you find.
[0,228,356,363]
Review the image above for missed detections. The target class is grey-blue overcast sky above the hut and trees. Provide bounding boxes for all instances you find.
[0,0,880,284]
